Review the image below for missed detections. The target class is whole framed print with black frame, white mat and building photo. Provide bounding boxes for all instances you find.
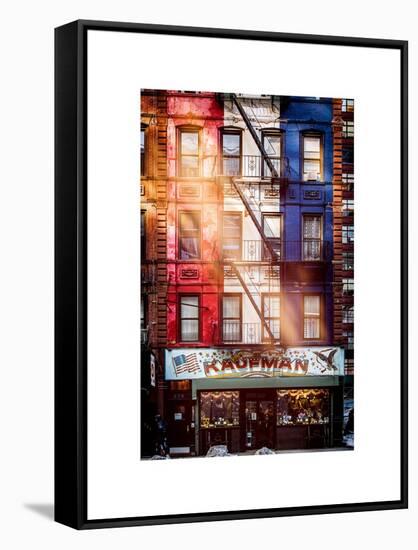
[55,21,407,529]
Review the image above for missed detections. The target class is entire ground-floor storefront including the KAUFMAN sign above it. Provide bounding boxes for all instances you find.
[166,348,343,455]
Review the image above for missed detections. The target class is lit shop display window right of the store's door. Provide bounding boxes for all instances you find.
[277,388,329,426]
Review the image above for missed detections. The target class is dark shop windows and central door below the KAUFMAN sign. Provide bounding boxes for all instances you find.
[198,388,332,454]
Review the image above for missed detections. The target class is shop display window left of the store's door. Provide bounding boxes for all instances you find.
[200,391,239,428]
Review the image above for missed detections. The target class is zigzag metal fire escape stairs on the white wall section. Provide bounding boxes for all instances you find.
[223,94,283,344]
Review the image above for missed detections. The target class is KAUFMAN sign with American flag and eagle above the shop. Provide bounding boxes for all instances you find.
[165,347,344,380]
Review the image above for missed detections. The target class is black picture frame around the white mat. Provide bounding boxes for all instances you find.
[55,20,408,529]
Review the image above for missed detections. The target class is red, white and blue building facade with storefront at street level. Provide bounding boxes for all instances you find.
[141,90,352,458]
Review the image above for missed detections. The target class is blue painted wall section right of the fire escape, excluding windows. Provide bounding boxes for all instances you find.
[280,97,333,346]
